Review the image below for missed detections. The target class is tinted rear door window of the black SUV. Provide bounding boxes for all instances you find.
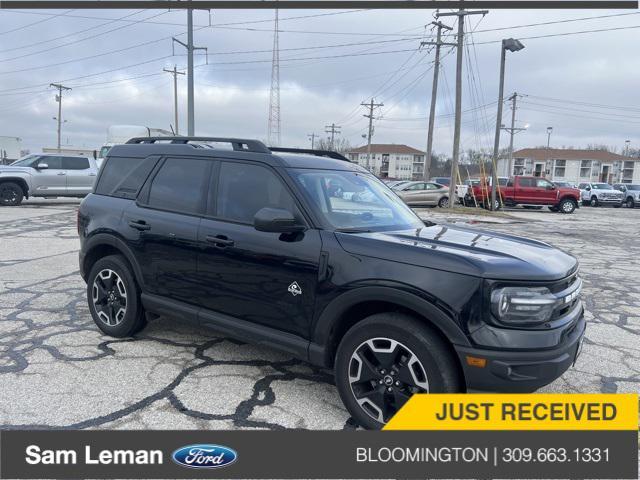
[147,158,209,214]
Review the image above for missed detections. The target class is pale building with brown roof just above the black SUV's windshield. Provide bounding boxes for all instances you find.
[347,143,425,180]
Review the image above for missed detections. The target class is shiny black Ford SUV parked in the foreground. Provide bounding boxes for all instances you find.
[78,137,585,428]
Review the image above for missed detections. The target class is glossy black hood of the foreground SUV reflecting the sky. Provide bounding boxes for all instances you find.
[336,225,578,281]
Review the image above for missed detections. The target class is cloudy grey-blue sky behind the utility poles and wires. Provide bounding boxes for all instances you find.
[0,5,640,154]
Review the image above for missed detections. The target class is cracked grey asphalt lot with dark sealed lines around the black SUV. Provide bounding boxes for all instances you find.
[0,200,640,429]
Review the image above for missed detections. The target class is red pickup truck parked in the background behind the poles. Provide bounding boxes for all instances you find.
[473,176,580,213]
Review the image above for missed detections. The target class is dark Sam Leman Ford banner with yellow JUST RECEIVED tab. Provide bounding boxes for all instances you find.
[0,394,638,479]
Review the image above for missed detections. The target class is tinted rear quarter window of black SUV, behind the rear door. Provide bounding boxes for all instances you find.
[95,157,158,199]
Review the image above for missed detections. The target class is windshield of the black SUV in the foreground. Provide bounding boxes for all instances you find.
[290,169,424,231]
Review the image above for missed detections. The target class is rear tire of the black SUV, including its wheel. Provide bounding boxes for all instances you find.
[87,255,147,338]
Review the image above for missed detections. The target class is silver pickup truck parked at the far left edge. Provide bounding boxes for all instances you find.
[0,153,98,206]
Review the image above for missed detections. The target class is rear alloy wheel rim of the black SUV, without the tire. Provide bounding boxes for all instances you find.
[91,269,127,327]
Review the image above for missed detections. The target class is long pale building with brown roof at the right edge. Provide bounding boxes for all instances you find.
[498,148,640,183]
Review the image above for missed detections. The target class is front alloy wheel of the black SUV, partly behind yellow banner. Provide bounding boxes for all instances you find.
[348,337,429,423]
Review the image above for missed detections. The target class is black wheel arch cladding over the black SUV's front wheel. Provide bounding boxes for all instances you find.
[310,287,469,370]
